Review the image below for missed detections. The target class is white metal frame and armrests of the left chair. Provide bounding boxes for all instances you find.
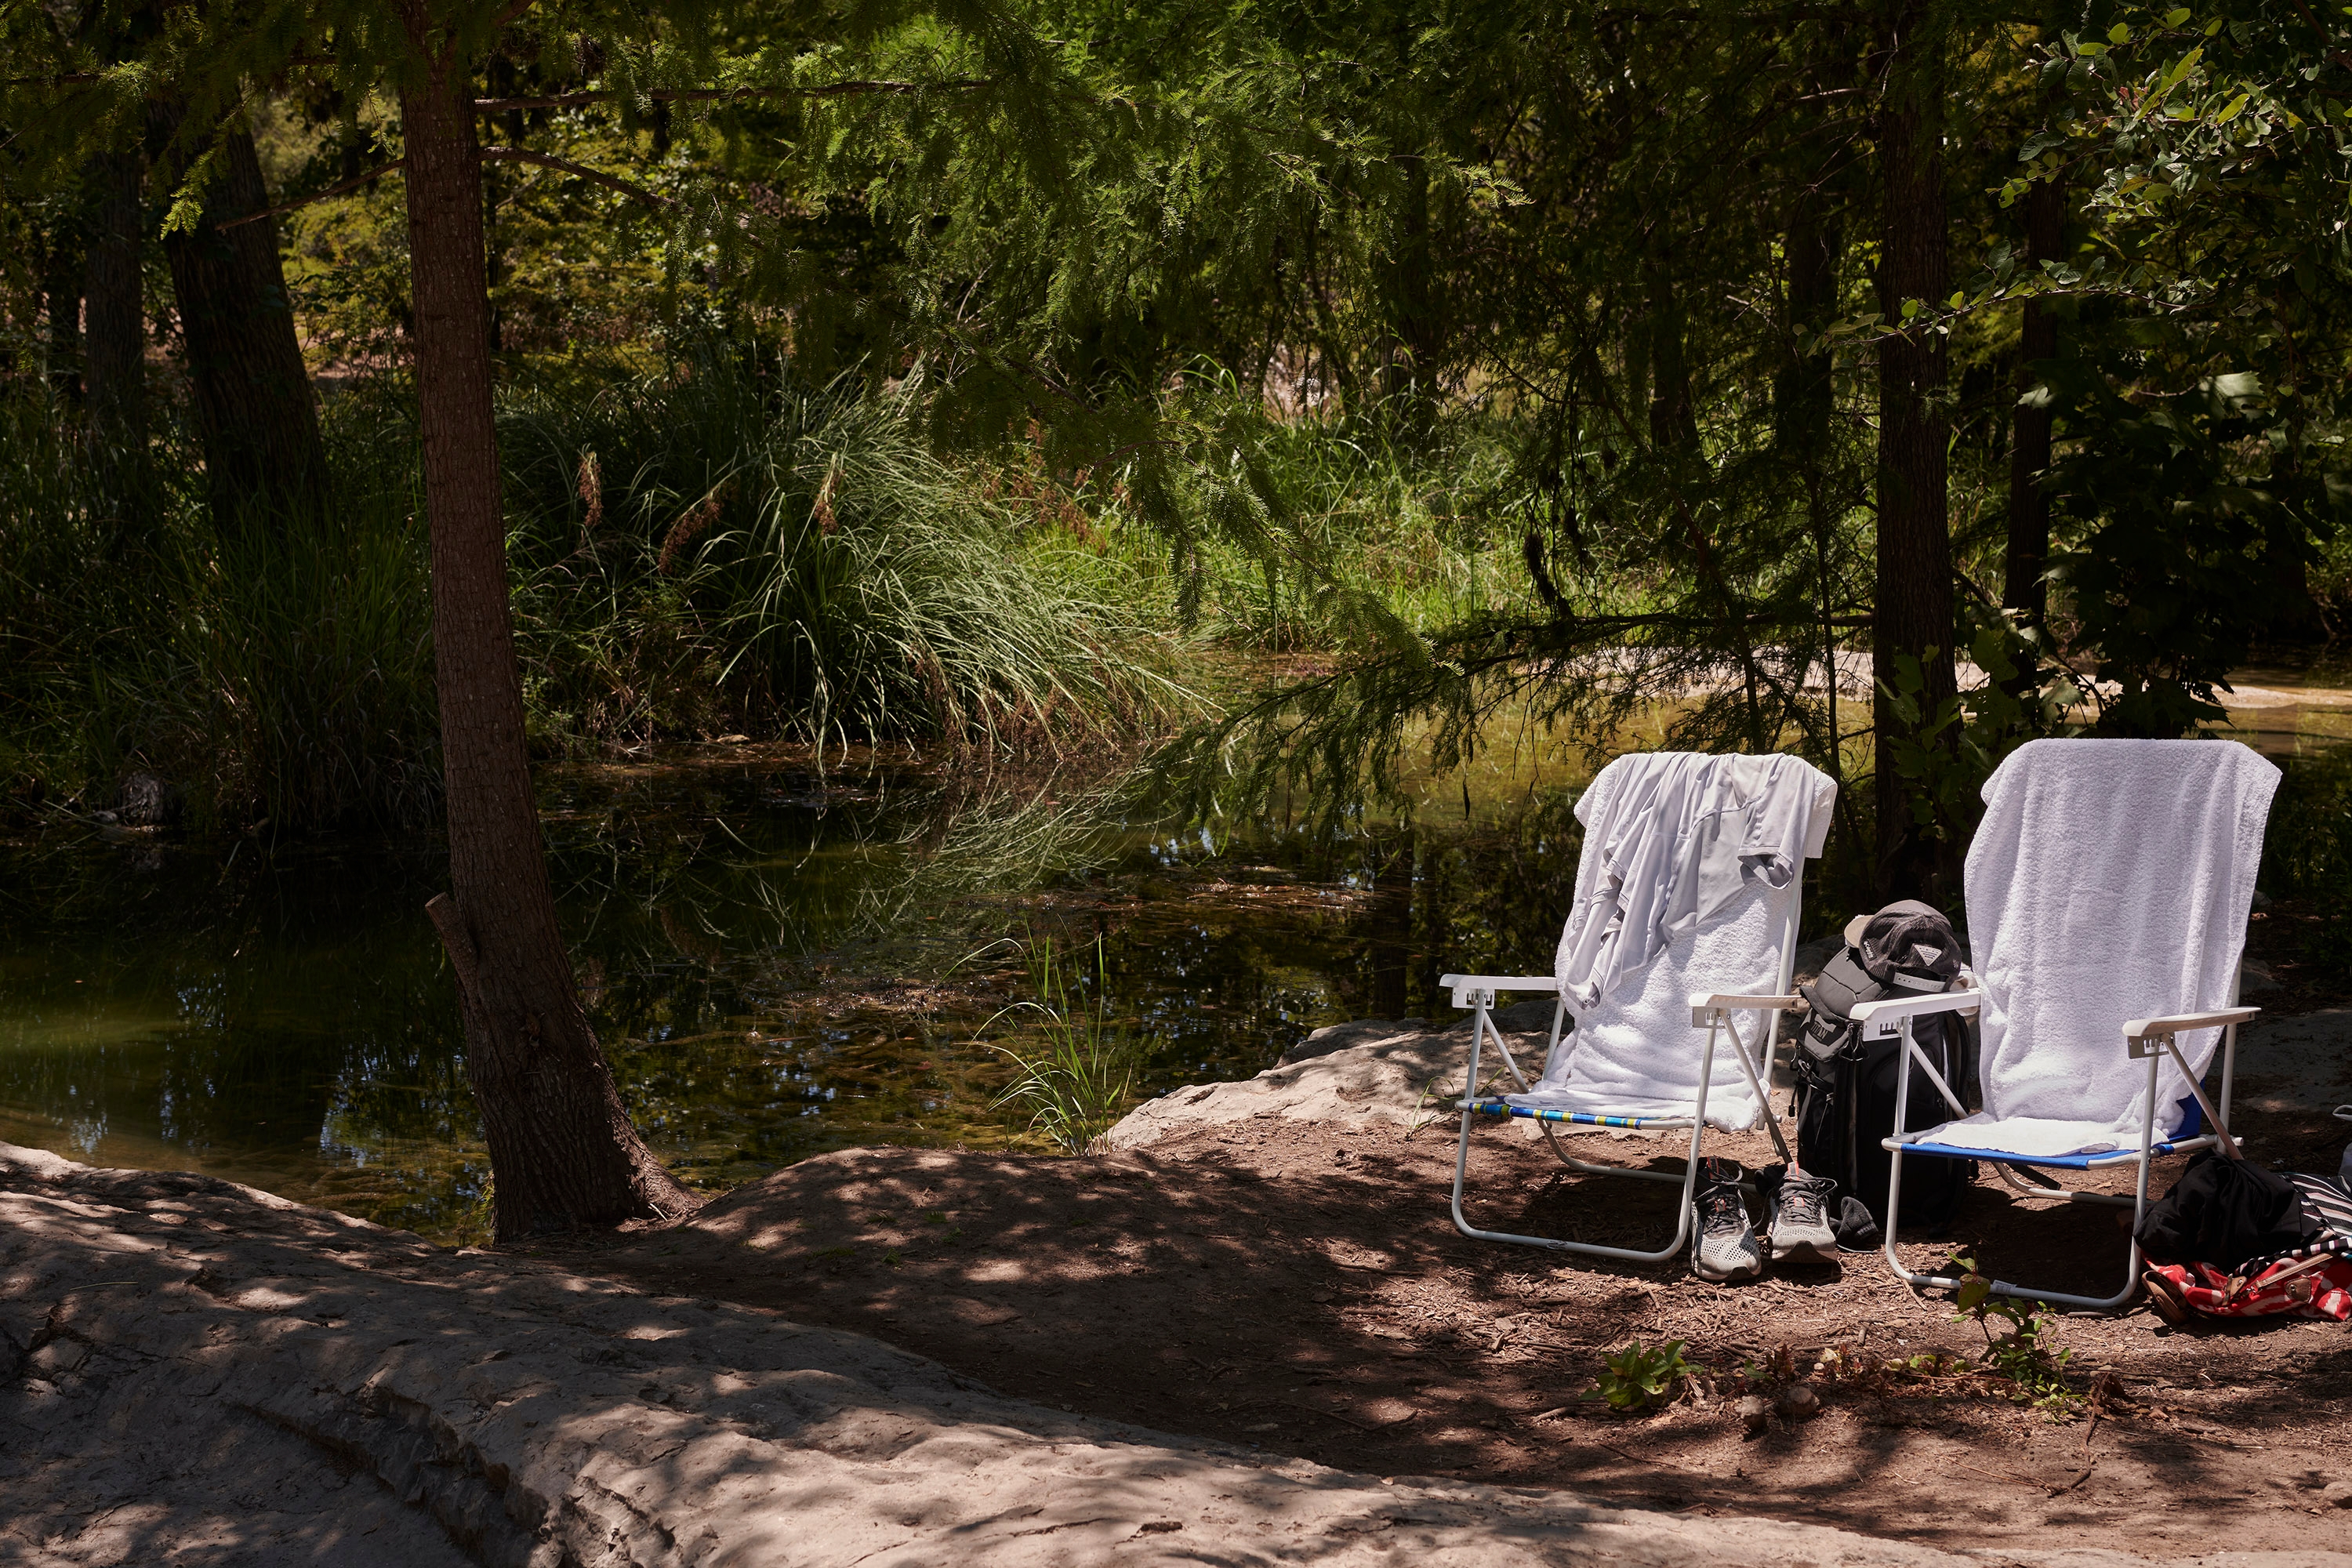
[1437,912,1804,1262]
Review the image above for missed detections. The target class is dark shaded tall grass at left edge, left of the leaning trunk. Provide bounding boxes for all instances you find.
[0,380,440,832]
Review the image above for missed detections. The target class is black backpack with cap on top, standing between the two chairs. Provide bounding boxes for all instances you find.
[1795,898,1976,1248]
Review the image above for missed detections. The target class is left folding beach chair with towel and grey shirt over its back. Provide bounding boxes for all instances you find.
[1442,753,1837,1262]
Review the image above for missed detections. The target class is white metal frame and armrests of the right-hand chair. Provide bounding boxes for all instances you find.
[1853,989,2263,1312]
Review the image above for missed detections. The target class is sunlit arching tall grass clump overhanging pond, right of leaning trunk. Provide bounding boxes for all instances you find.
[503,343,1188,748]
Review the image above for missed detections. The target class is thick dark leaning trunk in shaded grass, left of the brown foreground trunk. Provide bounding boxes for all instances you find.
[155,106,327,529]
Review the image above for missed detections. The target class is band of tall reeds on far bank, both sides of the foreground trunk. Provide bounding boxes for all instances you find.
[0,341,1195,832]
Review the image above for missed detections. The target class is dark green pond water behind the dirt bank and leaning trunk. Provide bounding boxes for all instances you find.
[0,673,2352,1241]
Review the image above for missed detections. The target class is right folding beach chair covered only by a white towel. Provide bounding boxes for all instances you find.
[1853,741,2279,1309]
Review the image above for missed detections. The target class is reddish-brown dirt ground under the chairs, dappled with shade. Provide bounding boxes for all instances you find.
[569,1072,2352,1556]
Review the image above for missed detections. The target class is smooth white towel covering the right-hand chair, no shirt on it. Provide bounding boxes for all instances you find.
[1907,741,2279,1154]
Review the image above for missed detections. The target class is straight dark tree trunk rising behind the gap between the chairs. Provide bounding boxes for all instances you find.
[1870,0,1957,898]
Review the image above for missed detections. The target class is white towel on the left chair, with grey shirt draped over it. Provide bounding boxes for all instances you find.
[1508,753,1837,1131]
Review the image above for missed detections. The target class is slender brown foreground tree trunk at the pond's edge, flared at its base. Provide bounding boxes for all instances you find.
[400,58,694,1239]
